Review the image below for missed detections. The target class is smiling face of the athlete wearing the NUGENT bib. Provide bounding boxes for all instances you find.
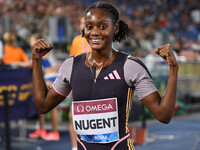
[85,8,117,51]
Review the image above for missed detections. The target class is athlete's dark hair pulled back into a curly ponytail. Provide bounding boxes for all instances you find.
[81,1,132,43]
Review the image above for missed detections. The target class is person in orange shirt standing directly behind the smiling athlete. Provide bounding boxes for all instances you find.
[69,15,92,150]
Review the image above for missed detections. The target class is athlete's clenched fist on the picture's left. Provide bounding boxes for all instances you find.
[31,39,53,59]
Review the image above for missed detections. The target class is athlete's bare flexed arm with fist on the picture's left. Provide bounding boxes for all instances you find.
[32,39,65,113]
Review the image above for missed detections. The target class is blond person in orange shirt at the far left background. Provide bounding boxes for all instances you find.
[3,32,29,65]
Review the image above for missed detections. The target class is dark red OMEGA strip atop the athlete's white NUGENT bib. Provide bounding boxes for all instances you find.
[73,100,116,115]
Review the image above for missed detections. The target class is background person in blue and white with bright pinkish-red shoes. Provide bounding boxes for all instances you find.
[29,33,60,141]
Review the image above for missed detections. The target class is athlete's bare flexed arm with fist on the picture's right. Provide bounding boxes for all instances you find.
[142,44,179,123]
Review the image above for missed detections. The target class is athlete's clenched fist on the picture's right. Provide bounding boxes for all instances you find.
[156,44,178,67]
